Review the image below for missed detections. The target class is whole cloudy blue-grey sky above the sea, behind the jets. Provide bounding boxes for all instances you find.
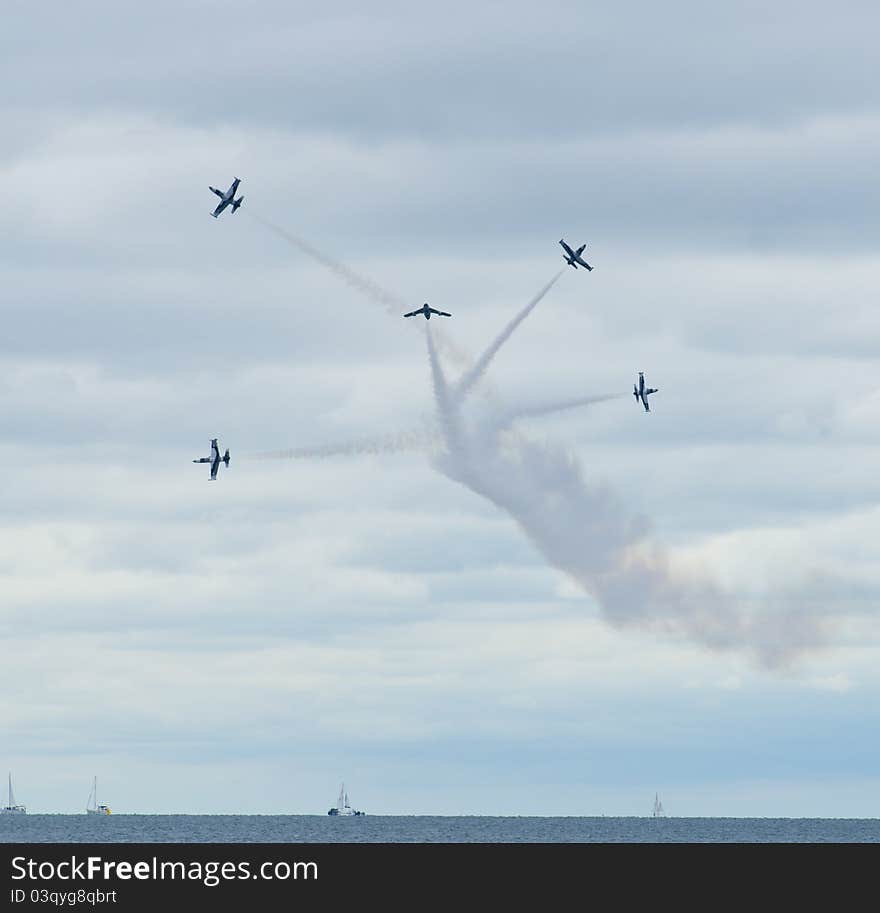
[0,0,880,817]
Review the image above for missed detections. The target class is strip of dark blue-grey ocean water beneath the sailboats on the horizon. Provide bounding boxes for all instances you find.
[0,814,880,843]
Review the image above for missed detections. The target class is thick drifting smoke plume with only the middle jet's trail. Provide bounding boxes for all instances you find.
[428,329,824,667]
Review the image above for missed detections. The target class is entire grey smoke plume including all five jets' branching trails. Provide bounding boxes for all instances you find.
[254,216,830,667]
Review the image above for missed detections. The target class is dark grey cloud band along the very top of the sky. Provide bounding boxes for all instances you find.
[4,2,878,138]
